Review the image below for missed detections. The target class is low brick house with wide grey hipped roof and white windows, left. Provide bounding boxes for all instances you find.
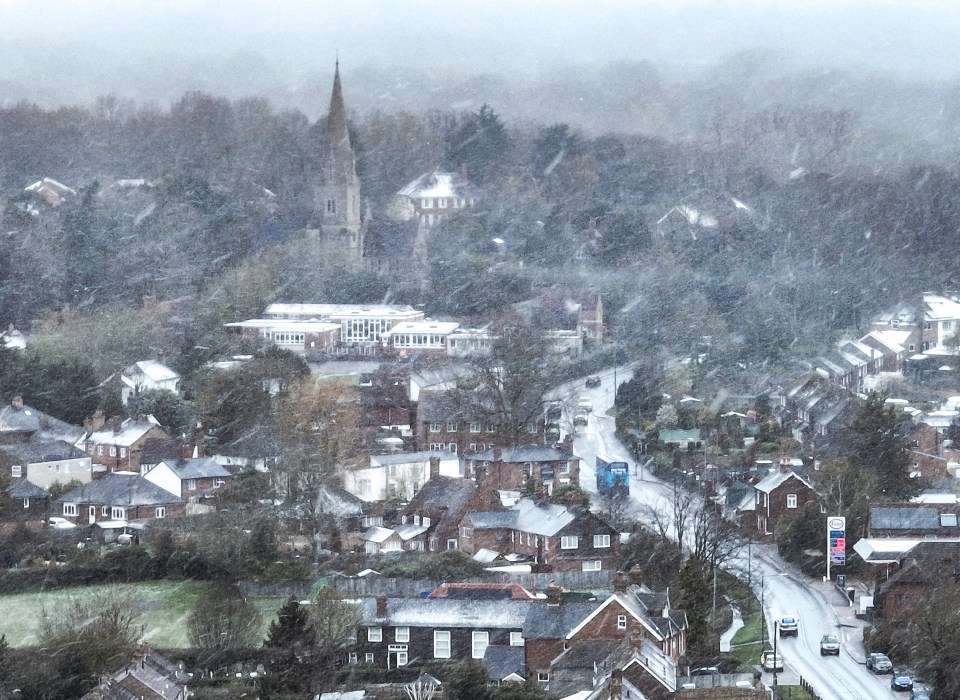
[51,472,185,529]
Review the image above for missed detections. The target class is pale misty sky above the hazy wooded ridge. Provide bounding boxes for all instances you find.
[0,0,960,110]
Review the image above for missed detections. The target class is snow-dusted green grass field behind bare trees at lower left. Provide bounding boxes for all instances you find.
[0,581,284,648]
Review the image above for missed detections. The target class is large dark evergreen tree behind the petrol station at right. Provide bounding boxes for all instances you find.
[847,392,920,501]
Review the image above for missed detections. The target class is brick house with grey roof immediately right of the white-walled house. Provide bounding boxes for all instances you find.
[464,446,580,495]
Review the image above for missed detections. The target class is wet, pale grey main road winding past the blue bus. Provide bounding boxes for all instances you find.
[557,368,920,700]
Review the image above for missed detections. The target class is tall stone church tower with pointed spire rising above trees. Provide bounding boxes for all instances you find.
[313,61,364,265]
